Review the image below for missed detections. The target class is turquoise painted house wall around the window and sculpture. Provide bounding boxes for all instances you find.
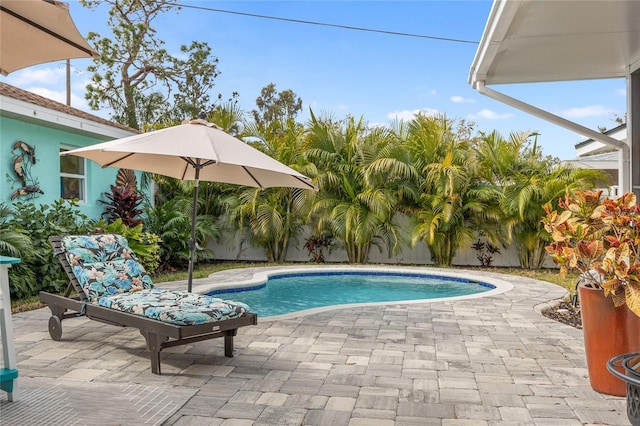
[0,116,144,219]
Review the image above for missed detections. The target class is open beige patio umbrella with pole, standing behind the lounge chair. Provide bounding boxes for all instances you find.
[60,119,316,291]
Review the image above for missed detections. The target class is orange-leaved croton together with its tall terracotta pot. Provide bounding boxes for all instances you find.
[543,191,640,396]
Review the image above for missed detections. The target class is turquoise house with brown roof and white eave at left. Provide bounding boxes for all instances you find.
[0,82,139,219]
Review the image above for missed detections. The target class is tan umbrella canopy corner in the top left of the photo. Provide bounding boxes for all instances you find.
[0,0,98,75]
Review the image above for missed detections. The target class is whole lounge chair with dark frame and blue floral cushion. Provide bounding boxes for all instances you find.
[40,234,258,374]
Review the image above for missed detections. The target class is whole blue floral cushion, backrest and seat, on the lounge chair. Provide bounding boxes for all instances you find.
[61,234,249,325]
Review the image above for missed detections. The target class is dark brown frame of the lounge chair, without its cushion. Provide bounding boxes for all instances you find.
[40,236,258,375]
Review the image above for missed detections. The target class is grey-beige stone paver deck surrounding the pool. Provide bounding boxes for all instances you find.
[0,267,629,426]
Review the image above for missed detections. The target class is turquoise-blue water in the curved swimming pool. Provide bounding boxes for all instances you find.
[209,271,495,317]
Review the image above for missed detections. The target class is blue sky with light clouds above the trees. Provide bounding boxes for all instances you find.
[0,0,626,159]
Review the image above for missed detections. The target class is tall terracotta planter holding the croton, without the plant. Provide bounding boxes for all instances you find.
[578,286,640,396]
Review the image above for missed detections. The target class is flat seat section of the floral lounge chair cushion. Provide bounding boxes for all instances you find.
[98,288,249,325]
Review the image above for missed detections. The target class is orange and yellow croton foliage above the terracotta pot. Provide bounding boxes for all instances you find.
[543,191,640,316]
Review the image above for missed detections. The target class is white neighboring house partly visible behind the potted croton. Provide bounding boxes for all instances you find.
[570,124,627,197]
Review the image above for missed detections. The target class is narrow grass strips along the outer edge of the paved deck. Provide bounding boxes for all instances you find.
[11,262,578,314]
